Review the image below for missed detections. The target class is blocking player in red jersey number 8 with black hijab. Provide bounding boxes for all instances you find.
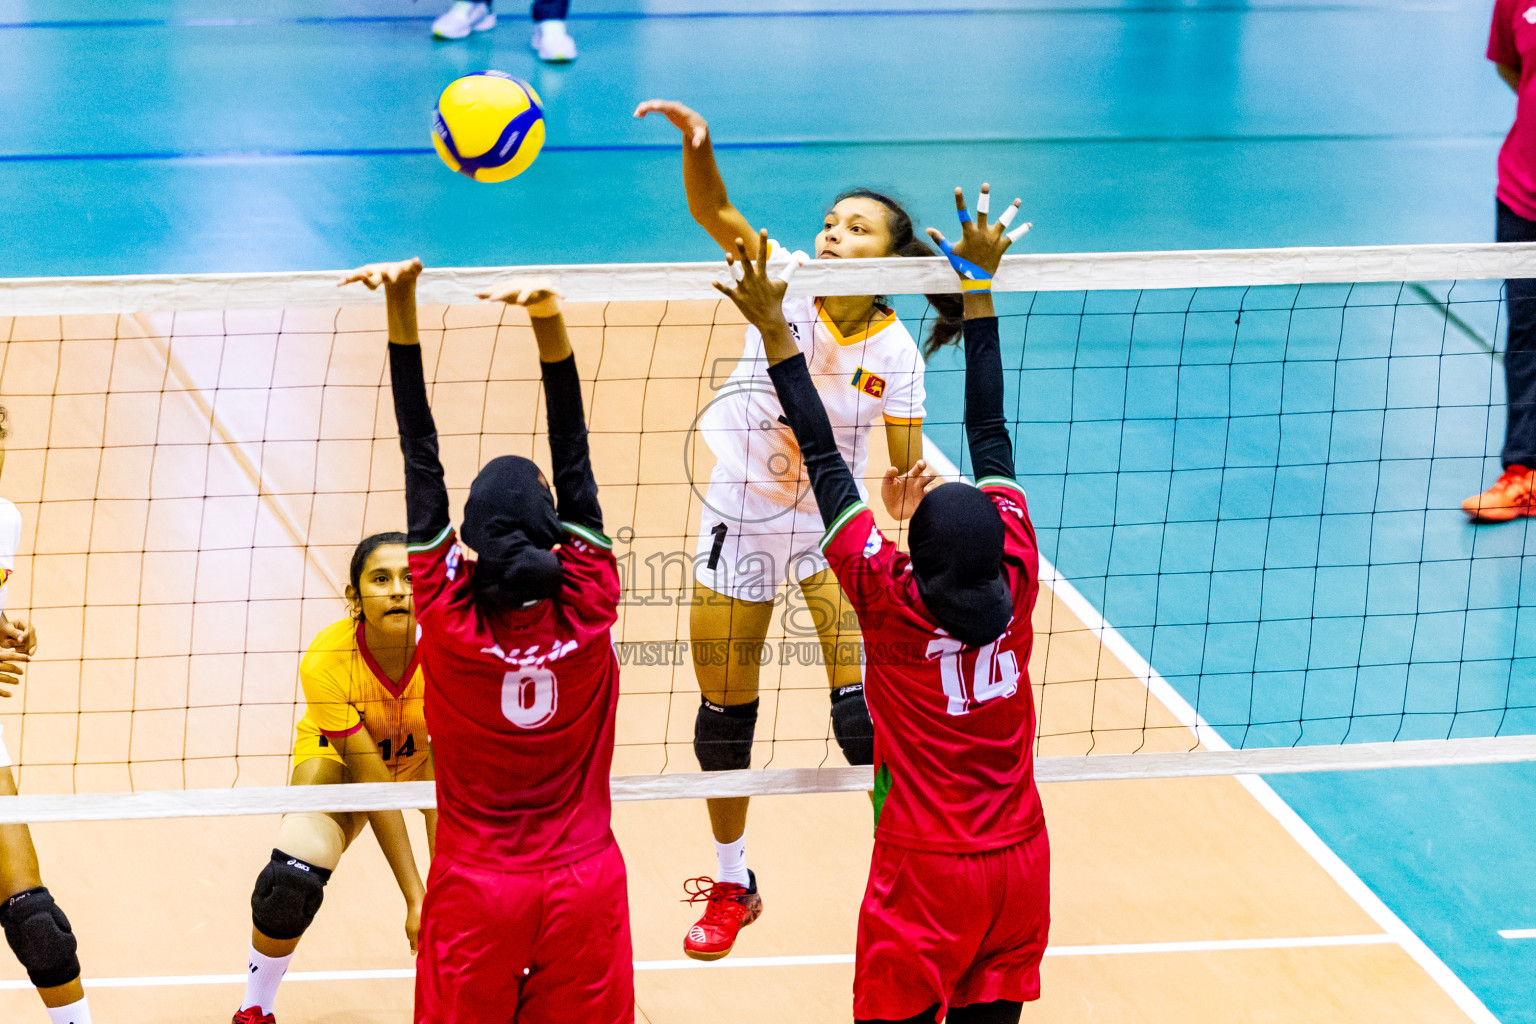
[347,259,634,1024]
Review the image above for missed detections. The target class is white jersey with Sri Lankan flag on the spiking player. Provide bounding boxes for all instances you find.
[699,241,926,510]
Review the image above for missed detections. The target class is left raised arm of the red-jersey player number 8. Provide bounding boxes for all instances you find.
[343,259,450,555]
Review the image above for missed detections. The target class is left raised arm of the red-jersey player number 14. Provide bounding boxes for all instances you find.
[714,230,860,527]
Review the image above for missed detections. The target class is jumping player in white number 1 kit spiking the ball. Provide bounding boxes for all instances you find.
[634,100,962,960]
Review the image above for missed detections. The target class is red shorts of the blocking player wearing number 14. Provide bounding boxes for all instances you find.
[854,829,1051,1021]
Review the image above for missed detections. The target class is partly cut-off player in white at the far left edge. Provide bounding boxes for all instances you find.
[0,408,91,1024]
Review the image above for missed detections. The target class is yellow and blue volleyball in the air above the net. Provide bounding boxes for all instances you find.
[432,71,544,181]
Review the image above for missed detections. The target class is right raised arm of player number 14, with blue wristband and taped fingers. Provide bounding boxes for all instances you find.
[928,184,1029,484]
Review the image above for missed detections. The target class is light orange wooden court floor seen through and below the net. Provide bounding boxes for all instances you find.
[0,302,1492,1024]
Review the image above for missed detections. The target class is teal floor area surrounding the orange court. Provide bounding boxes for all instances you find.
[0,0,1536,1024]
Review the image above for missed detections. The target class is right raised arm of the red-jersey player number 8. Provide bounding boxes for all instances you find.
[481,279,602,533]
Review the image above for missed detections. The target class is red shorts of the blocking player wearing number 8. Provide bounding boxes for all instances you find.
[415,843,634,1024]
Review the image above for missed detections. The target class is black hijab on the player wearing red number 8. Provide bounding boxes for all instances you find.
[464,454,565,608]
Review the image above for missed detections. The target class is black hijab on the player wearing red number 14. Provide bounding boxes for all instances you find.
[908,484,1014,646]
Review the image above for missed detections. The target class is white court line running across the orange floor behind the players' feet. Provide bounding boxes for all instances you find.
[0,933,1396,990]
